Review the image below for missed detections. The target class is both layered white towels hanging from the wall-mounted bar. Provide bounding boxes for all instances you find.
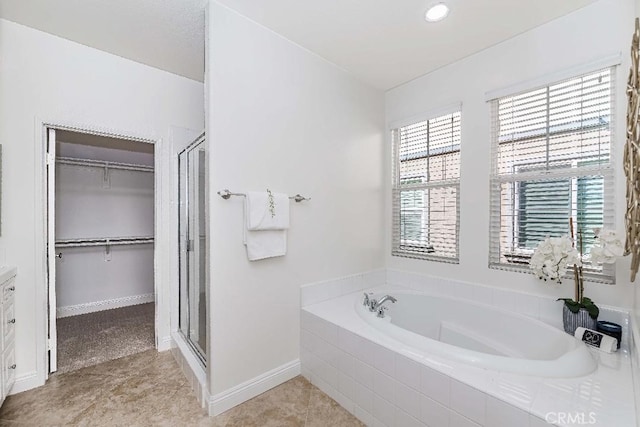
[244,190,289,261]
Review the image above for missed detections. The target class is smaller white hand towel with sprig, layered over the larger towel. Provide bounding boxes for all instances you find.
[246,191,289,230]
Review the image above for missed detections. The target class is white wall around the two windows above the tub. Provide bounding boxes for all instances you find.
[385,0,635,307]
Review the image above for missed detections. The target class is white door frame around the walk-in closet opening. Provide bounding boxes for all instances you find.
[34,117,161,386]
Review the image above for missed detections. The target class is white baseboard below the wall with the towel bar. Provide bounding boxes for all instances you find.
[209,359,300,416]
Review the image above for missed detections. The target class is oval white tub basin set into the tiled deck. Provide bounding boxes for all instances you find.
[354,291,597,378]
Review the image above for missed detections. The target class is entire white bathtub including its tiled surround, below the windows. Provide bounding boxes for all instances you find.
[300,270,636,427]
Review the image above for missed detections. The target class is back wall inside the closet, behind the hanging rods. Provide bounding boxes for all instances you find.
[56,142,154,317]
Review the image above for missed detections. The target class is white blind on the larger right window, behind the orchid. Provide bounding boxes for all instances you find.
[489,68,615,282]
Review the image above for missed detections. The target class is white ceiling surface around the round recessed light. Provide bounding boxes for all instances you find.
[0,0,596,90]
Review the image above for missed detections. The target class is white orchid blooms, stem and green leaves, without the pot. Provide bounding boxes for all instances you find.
[529,223,624,319]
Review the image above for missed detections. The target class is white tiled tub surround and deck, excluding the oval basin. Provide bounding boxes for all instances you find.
[301,271,636,427]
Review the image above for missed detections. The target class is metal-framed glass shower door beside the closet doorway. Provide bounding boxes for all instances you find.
[178,136,207,364]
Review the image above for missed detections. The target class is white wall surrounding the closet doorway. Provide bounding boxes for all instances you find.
[0,20,204,392]
